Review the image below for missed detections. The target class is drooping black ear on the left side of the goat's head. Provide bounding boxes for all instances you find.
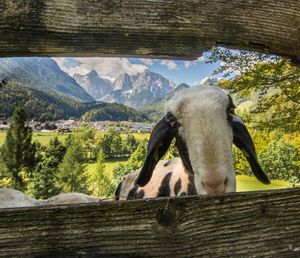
[136,114,177,186]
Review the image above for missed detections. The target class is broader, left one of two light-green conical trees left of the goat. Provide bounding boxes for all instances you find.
[58,139,88,193]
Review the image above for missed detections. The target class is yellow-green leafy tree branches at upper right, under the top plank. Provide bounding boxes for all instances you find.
[208,48,300,132]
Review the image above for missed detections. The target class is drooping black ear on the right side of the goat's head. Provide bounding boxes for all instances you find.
[232,116,271,184]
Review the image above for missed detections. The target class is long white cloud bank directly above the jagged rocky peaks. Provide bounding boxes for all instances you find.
[53,57,147,81]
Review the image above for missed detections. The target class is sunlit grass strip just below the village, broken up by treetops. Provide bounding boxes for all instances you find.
[0,131,149,146]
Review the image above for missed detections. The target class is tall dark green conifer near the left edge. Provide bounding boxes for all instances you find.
[1,107,36,191]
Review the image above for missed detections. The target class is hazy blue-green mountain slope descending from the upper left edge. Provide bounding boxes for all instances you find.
[0,57,95,102]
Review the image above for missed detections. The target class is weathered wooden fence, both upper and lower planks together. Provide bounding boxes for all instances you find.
[0,0,300,257]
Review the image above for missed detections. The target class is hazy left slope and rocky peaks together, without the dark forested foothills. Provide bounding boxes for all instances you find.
[0,57,180,108]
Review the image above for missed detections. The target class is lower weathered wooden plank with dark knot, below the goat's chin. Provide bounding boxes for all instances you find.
[0,188,300,257]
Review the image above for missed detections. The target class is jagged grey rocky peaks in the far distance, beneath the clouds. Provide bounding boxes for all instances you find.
[73,70,176,108]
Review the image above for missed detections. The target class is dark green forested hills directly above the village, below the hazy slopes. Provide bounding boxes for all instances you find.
[0,81,146,121]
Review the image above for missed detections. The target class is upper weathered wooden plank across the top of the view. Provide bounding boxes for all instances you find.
[0,0,300,61]
